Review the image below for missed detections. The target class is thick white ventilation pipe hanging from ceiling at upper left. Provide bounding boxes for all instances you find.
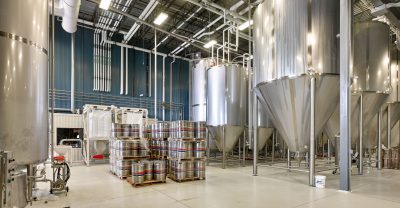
[61,0,81,33]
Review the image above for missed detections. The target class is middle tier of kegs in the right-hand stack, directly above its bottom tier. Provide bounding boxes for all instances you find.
[168,139,207,159]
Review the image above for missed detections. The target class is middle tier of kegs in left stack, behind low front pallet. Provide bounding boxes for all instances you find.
[110,139,150,158]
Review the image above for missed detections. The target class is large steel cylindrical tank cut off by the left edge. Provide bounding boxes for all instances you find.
[0,0,49,165]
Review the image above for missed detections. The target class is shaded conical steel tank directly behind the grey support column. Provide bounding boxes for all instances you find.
[325,22,390,148]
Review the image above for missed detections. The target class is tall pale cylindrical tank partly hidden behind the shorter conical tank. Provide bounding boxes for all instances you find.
[191,59,213,121]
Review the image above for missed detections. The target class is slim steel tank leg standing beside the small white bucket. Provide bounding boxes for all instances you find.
[309,75,315,186]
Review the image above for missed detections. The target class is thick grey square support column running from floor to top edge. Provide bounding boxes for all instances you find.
[339,0,353,191]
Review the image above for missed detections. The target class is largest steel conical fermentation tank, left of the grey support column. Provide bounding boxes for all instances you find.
[253,0,339,152]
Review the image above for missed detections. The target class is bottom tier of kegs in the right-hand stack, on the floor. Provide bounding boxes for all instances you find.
[169,160,206,182]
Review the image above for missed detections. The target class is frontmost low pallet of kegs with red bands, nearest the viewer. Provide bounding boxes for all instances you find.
[130,160,166,185]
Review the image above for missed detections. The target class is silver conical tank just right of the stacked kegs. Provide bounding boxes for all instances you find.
[207,64,247,152]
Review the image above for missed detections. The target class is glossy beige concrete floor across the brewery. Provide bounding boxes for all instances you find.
[32,162,400,208]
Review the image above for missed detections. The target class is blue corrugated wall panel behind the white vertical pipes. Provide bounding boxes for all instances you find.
[51,21,189,120]
